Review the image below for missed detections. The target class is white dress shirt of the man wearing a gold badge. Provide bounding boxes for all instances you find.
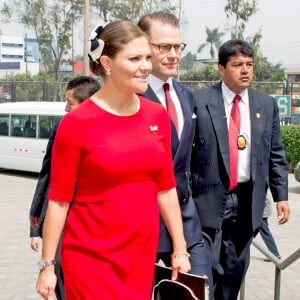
[222,82,251,182]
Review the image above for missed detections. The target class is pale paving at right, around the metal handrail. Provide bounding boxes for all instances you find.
[245,174,300,300]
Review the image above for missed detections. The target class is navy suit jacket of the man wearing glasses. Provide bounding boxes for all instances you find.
[142,80,202,252]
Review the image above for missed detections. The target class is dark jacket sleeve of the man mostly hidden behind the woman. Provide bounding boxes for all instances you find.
[29,124,59,237]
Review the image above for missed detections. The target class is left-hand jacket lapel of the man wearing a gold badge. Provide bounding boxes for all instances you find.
[207,84,230,176]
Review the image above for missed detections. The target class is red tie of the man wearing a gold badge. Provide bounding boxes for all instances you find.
[228,95,241,190]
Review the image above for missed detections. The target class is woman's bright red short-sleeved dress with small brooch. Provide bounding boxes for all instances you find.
[48,97,175,300]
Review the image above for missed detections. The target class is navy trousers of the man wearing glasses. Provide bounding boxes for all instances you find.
[156,239,214,300]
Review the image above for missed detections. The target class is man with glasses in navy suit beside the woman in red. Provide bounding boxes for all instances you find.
[138,12,213,299]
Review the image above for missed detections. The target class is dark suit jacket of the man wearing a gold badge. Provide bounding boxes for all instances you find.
[191,84,288,248]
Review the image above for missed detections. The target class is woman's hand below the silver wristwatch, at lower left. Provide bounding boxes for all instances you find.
[36,266,57,300]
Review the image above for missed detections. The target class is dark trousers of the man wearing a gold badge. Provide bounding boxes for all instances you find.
[202,182,252,300]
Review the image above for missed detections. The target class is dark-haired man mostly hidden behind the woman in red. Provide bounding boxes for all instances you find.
[29,76,100,300]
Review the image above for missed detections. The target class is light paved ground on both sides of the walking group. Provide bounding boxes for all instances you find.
[0,170,300,300]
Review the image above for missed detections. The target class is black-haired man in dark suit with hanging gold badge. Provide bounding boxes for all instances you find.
[191,40,289,300]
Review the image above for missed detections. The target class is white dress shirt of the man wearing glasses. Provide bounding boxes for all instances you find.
[148,74,184,139]
